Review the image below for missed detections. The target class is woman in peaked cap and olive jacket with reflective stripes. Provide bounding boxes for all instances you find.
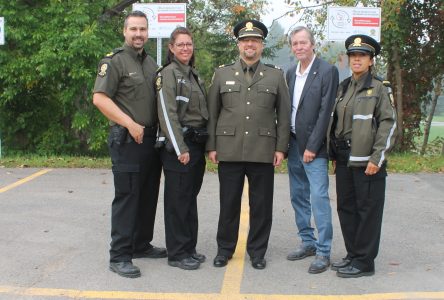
[328,35,396,278]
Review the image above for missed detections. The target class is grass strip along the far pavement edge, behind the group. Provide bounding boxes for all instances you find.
[0,153,444,173]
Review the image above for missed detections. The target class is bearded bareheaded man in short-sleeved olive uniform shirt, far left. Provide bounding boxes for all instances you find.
[93,11,166,278]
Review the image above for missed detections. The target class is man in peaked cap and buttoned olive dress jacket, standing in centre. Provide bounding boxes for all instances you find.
[207,20,291,269]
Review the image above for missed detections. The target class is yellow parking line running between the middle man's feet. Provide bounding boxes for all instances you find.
[221,182,250,295]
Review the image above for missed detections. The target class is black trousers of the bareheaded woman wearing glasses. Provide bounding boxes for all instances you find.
[161,138,206,260]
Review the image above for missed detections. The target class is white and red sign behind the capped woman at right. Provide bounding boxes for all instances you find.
[327,6,381,42]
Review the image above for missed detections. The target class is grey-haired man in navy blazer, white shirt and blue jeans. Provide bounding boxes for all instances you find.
[286,26,339,274]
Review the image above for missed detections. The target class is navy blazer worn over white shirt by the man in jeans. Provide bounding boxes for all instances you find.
[286,57,339,158]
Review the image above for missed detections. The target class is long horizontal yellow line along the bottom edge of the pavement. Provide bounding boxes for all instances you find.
[0,286,444,300]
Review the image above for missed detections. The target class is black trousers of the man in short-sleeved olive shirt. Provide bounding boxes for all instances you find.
[108,134,162,262]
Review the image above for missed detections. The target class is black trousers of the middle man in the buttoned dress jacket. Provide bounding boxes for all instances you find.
[217,161,274,258]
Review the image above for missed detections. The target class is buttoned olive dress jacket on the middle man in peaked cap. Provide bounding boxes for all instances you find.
[206,60,290,163]
